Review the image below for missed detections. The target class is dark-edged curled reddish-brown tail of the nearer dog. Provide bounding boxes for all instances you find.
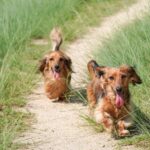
[87,60,99,79]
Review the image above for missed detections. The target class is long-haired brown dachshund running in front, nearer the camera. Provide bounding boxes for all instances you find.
[87,60,142,136]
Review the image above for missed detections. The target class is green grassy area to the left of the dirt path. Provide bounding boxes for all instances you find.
[0,0,135,150]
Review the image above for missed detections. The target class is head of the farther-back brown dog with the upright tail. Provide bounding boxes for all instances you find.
[39,51,72,79]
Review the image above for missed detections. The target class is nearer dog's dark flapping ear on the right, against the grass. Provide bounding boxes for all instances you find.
[119,66,142,85]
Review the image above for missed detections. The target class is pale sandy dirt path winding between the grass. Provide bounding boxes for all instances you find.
[17,0,148,150]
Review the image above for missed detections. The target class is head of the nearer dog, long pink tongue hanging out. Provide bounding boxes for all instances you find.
[105,65,142,107]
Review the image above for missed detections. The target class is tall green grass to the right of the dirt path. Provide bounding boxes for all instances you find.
[95,10,150,148]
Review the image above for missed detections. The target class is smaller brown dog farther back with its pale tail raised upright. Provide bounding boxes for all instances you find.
[39,28,72,100]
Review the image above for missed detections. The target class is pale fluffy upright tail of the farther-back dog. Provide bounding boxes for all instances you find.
[50,28,63,51]
